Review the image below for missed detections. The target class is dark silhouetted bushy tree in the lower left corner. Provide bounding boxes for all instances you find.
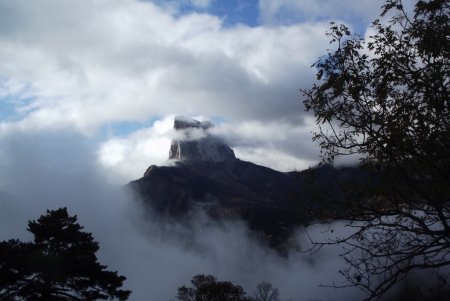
[0,208,130,301]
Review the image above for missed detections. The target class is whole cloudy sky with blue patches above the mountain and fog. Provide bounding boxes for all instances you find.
[0,0,400,182]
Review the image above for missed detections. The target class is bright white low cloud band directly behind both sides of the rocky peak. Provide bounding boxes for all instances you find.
[97,115,319,183]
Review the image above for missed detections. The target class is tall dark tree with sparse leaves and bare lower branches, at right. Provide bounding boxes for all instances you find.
[302,0,450,299]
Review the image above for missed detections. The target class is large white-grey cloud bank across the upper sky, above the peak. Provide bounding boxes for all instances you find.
[0,0,326,133]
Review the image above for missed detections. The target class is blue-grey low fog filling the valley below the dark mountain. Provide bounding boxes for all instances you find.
[0,135,362,301]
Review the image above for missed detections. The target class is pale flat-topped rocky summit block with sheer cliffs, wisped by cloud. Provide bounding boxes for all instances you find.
[169,116,236,162]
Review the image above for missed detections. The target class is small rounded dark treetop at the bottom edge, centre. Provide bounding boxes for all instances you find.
[176,274,251,301]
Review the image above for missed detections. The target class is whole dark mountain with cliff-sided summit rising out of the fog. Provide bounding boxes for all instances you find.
[129,117,368,247]
